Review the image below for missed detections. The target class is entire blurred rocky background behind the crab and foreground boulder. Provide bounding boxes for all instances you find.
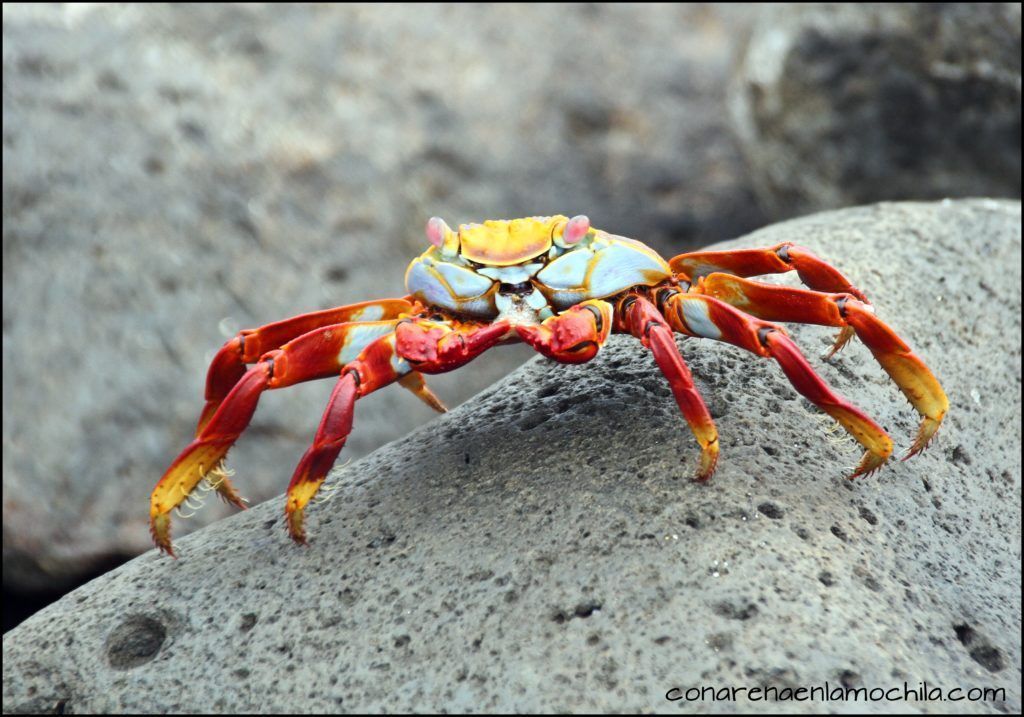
[3,5,1021,629]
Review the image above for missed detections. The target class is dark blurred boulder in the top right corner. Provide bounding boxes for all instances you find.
[730,3,1021,218]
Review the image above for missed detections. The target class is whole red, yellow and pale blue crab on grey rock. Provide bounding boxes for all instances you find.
[150,215,949,555]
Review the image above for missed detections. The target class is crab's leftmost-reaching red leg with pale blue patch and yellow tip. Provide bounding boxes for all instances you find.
[150,320,397,555]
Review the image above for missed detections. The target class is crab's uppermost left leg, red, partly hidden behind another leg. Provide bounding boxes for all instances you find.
[196,299,417,435]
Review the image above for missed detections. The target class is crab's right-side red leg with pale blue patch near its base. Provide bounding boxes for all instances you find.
[658,289,893,478]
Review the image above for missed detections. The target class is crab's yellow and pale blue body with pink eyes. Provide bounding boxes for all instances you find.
[406,215,672,319]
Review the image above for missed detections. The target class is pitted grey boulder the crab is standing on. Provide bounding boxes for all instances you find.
[3,200,1021,713]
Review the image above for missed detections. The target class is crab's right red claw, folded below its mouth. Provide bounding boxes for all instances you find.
[515,299,612,364]
